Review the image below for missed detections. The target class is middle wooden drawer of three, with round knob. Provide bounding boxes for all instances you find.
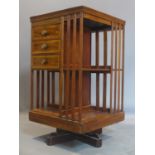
[32,40,61,54]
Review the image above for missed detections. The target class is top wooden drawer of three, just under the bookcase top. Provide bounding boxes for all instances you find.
[32,24,60,40]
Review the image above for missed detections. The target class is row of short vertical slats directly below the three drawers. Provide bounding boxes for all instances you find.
[30,70,59,110]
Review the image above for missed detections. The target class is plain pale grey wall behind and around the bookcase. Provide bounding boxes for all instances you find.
[19,0,135,113]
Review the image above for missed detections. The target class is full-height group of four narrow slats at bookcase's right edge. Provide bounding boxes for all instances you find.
[110,23,124,113]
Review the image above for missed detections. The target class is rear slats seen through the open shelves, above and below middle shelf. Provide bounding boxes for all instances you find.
[90,31,111,112]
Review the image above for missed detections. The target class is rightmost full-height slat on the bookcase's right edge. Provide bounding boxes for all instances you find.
[121,26,125,111]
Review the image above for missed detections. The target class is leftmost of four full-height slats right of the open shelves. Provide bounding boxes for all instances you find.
[110,23,114,113]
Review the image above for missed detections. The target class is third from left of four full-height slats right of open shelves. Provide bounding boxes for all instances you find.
[117,24,121,111]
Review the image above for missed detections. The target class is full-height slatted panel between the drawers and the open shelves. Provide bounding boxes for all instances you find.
[62,13,83,120]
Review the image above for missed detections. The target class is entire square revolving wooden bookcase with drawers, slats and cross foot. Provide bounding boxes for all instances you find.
[29,6,125,146]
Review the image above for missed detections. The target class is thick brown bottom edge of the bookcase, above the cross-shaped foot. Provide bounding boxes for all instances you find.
[29,111,124,134]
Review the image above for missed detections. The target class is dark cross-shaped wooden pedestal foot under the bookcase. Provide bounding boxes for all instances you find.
[46,129,102,147]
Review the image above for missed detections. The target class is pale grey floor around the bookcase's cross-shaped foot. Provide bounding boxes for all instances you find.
[19,113,135,155]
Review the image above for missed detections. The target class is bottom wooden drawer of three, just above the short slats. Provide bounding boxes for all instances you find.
[32,55,59,69]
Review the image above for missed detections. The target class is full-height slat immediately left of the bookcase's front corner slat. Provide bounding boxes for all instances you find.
[71,14,77,120]
